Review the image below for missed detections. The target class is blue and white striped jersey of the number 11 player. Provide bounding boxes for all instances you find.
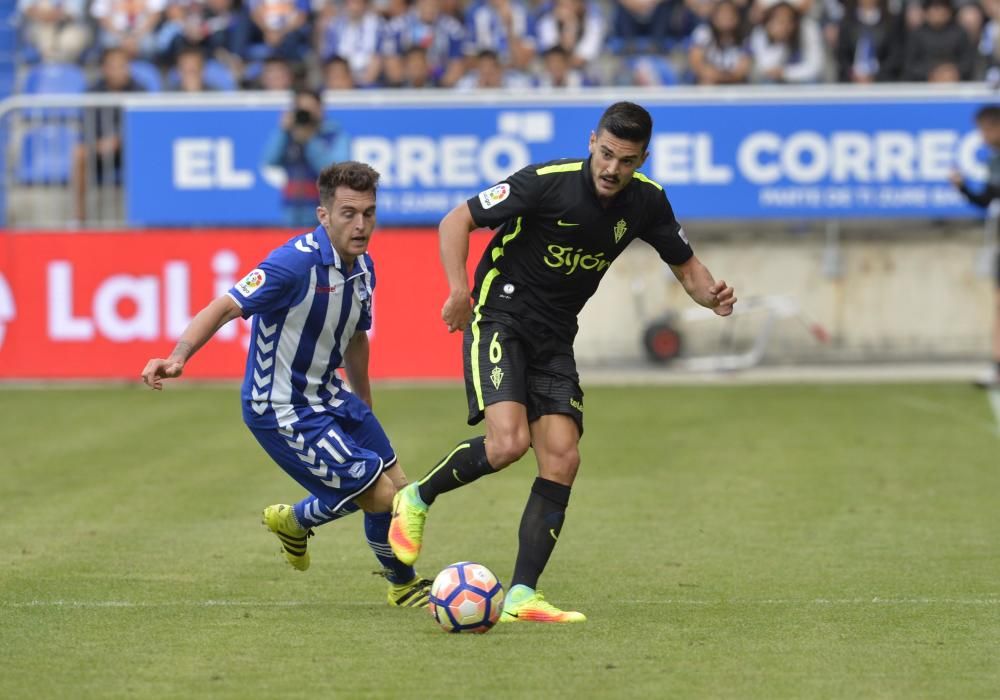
[228,226,375,428]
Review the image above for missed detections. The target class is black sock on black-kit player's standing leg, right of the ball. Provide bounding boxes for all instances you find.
[508,477,570,590]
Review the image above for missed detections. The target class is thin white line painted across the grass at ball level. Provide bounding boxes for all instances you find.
[0,596,1000,609]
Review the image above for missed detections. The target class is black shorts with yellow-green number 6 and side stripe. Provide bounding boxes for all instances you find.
[463,309,583,436]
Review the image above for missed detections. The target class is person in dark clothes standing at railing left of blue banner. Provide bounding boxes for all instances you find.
[73,47,142,222]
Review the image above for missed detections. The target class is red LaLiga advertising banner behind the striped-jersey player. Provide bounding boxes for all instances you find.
[0,229,489,380]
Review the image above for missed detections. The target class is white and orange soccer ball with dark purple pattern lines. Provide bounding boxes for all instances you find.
[427,561,503,632]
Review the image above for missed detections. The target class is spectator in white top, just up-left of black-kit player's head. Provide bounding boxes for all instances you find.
[536,0,607,68]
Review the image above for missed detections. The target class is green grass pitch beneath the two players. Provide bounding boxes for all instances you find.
[0,385,1000,700]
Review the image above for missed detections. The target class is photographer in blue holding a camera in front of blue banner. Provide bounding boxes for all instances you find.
[263,89,349,228]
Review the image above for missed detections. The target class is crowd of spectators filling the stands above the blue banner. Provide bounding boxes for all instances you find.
[18,0,1000,91]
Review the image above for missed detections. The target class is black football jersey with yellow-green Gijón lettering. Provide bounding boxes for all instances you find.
[468,159,693,336]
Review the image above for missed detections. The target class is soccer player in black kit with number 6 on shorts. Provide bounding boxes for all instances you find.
[389,102,736,622]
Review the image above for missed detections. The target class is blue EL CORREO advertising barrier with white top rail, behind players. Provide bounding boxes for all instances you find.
[0,85,992,228]
